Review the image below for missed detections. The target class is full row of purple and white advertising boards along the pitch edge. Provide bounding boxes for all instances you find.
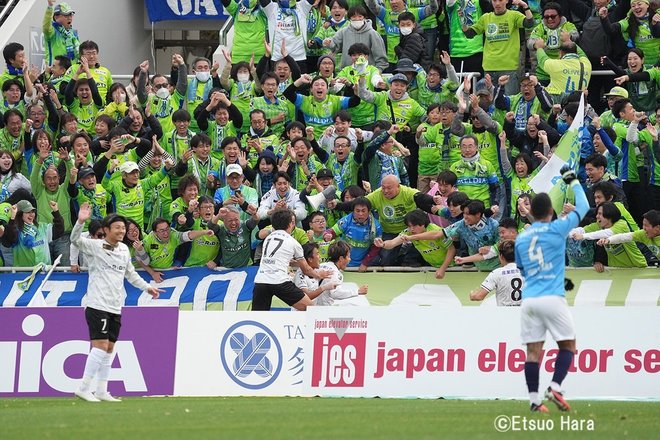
[0,307,660,400]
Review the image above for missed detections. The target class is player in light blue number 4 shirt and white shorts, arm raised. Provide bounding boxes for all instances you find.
[516,166,589,412]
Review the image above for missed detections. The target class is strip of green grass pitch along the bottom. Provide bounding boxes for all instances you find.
[0,397,660,440]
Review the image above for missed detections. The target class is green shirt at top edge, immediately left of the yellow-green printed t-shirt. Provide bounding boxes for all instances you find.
[447,0,484,58]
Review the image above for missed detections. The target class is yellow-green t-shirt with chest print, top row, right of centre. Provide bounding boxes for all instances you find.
[470,10,525,72]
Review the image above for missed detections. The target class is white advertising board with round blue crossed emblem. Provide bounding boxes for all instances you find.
[174,311,305,396]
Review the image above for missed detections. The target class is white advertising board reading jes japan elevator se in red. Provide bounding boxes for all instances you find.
[303,307,660,399]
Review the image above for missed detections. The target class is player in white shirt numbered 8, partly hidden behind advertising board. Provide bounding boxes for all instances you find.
[470,240,524,306]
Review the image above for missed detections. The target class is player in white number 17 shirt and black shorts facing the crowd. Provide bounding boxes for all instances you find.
[252,209,330,310]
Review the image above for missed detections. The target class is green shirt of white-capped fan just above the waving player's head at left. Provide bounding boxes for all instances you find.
[101,168,167,225]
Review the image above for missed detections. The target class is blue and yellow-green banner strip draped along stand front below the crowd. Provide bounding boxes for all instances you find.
[0,266,660,310]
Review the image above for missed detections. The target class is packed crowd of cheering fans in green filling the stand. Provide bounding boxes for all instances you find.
[0,0,660,281]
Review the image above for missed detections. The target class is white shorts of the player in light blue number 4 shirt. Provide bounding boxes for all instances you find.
[520,295,575,344]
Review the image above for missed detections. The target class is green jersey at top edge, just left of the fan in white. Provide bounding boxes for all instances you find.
[226,0,267,63]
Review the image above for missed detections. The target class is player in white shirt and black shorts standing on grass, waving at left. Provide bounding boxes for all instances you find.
[71,203,162,402]
